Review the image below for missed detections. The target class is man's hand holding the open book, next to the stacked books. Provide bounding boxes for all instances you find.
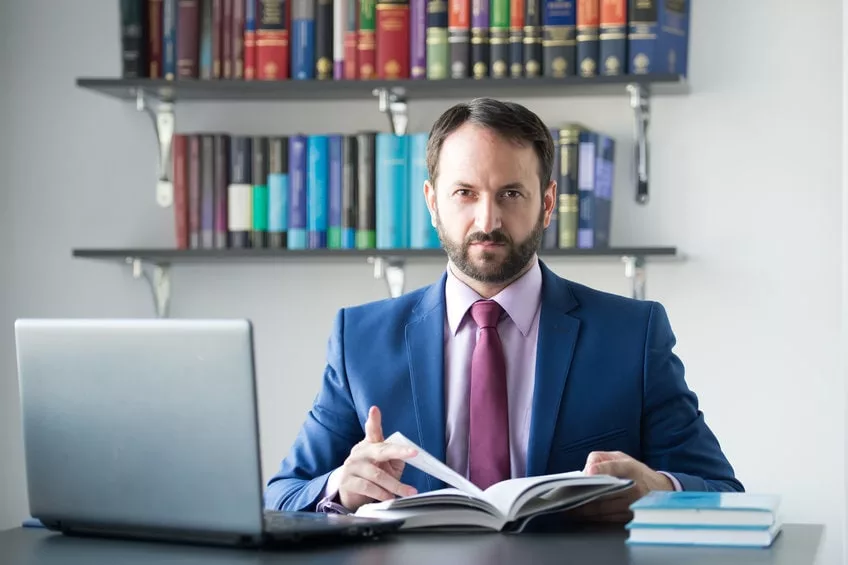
[565,451,674,523]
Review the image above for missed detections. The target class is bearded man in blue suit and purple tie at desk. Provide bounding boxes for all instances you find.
[266,99,742,521]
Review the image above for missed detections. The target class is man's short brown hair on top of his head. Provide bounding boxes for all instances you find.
[427,98,555,191]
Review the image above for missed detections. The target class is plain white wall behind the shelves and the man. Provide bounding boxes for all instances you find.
[0,0,846,564]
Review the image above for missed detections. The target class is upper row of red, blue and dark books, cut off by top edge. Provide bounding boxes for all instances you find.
[120,0,690,80]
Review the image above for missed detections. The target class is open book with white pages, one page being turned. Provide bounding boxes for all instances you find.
[356,432,633,532]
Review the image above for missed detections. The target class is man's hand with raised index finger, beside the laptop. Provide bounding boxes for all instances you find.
[339,406,417,512]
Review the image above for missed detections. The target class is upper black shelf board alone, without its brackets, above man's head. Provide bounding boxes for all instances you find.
[77,74,689,102]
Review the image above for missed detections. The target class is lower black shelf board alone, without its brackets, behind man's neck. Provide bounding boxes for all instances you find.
[73,247,677,263]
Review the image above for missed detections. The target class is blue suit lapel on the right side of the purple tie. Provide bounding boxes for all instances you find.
[527,261,580,476]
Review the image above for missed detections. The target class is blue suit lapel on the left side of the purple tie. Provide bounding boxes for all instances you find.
[406,275,446,489]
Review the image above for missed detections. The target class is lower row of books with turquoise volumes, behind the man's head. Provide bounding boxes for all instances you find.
[172,124,615,249]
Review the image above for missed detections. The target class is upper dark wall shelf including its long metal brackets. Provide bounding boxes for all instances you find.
[76,74,689,207]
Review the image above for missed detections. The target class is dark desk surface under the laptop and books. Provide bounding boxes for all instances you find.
[0,524,823,565]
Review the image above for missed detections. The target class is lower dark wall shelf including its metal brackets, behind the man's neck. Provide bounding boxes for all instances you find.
[73,247,683,317]
